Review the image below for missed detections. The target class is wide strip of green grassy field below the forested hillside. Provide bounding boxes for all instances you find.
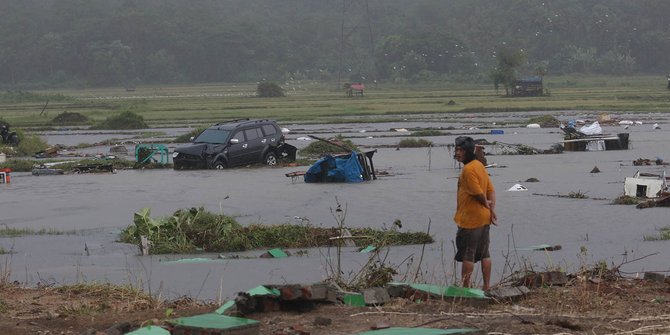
[2,75,668,128]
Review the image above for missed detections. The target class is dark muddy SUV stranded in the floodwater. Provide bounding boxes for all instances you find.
[172,119,297,169]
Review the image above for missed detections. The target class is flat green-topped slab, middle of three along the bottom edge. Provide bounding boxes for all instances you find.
[168,313,260,335]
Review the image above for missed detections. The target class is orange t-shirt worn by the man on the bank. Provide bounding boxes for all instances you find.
[454,159,494,228]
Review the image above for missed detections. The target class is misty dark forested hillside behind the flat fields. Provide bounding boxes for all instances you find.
[0,0,670,89]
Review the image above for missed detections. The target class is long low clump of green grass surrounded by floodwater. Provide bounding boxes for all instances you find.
[120,207,433,254]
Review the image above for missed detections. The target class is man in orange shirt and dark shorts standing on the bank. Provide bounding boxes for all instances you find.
[454,136,498,291]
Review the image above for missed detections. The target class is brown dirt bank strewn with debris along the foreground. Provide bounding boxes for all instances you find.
[0,277,670,335]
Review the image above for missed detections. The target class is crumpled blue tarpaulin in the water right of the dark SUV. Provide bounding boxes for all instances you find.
[305,152,363,183]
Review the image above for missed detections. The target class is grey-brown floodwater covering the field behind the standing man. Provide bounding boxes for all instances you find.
[0,112,670,301]
